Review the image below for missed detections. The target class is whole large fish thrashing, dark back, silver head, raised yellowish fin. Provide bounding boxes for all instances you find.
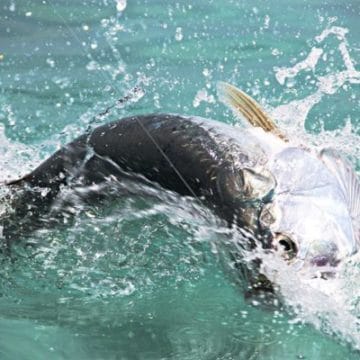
[0,82,360,287]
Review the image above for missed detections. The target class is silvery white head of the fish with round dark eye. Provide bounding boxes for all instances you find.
[260,148,359,271]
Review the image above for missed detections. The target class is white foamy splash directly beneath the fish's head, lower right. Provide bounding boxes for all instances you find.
[252,245,360,350]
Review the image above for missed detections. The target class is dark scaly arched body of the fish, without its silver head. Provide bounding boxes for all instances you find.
[2,114,274,242]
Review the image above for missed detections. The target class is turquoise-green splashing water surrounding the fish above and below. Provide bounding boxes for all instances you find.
[0,0,360,359]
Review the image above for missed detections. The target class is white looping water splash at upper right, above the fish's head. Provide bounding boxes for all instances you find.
[271,26,360,149]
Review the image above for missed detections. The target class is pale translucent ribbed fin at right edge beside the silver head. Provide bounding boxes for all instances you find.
[320,149,360,245]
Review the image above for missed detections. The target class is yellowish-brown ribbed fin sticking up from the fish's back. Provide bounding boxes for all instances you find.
[218,81,287,141]
